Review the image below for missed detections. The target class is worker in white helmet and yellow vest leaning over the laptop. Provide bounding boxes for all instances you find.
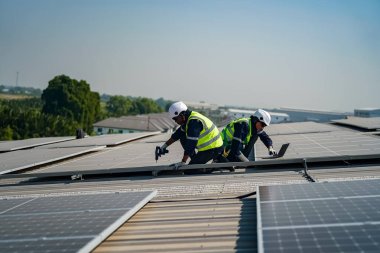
[219,109,276,162]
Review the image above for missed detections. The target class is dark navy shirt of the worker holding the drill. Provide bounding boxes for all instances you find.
[171,111,203,157]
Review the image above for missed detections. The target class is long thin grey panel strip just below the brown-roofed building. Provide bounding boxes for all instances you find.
[39,132,158,149]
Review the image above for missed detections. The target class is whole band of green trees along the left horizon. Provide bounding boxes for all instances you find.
[0,75,171,140]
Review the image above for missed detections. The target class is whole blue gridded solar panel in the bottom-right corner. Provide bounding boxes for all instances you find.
[257,180,380,252]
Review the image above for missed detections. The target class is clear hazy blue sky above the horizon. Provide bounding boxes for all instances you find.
[0,0,380,112]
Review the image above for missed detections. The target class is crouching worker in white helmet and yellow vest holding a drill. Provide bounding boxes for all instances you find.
[160,102,223,169]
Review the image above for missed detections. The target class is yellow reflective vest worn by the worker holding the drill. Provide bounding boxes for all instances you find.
[185,111,223,151]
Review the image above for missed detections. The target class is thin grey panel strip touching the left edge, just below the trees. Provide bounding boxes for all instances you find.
[0,136,75,152]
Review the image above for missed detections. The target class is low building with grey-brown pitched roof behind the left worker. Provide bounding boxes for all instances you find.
[93,113,177,135]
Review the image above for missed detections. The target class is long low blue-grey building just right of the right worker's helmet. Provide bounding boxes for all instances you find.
[272,108,350,122]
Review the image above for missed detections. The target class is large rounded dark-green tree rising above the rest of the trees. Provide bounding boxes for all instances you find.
[41,75,101,133]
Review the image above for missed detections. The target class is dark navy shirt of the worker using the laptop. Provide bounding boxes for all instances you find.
[230,119,272,156]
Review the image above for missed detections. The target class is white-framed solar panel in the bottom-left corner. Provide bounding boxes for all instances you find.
[0,191,156,252]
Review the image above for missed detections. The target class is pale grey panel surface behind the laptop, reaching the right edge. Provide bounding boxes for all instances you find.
[255,130,380,158]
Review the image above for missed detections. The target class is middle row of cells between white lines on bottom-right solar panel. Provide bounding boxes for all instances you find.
[261,196,380,227]
